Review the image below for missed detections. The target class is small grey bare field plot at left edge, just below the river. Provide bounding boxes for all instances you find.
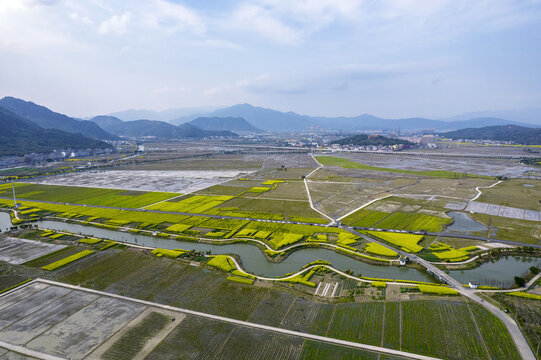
[0,237,66,264]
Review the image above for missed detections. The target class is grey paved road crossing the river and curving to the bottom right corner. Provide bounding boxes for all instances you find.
[344,228,536,360]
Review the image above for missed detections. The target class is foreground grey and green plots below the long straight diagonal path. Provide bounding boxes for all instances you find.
[0,280,416,360]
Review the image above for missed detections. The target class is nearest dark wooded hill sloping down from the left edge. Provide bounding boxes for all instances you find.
[0,108,111,156]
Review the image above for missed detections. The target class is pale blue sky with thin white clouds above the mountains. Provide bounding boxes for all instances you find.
[0,0,541,118]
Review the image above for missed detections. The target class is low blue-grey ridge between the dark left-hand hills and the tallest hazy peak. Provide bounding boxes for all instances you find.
[90,116,238,139]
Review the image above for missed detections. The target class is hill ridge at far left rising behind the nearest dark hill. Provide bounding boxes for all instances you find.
[0,96,115,140]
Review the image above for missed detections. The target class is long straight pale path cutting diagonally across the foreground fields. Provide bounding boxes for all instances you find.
[17,279,437,360]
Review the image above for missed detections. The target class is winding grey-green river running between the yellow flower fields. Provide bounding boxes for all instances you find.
[0,212,541,286]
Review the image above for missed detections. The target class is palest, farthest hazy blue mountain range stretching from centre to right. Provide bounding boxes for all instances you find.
[171,104,532,131]
